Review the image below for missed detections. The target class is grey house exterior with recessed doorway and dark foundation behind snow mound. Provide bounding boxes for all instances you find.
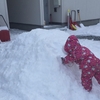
[6,0,100,30]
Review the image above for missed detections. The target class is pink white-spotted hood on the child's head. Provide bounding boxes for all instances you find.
[64,35,81,53]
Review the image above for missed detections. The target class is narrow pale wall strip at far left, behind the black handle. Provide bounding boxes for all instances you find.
[0,0,9,27]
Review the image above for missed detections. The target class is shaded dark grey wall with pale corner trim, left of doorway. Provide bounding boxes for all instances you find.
[7,0,43,25]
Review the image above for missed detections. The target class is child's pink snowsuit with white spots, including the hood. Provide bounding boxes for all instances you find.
[64,35,100,91]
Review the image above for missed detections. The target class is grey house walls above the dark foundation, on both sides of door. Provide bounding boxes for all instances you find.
[7,0,100,25]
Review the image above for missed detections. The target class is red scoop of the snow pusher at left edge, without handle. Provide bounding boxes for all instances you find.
[0,30,10,42]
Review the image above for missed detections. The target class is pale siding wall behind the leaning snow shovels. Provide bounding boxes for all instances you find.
[61,0,100,22]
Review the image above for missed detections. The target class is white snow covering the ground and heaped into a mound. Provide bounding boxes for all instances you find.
[0,24,100,100]
